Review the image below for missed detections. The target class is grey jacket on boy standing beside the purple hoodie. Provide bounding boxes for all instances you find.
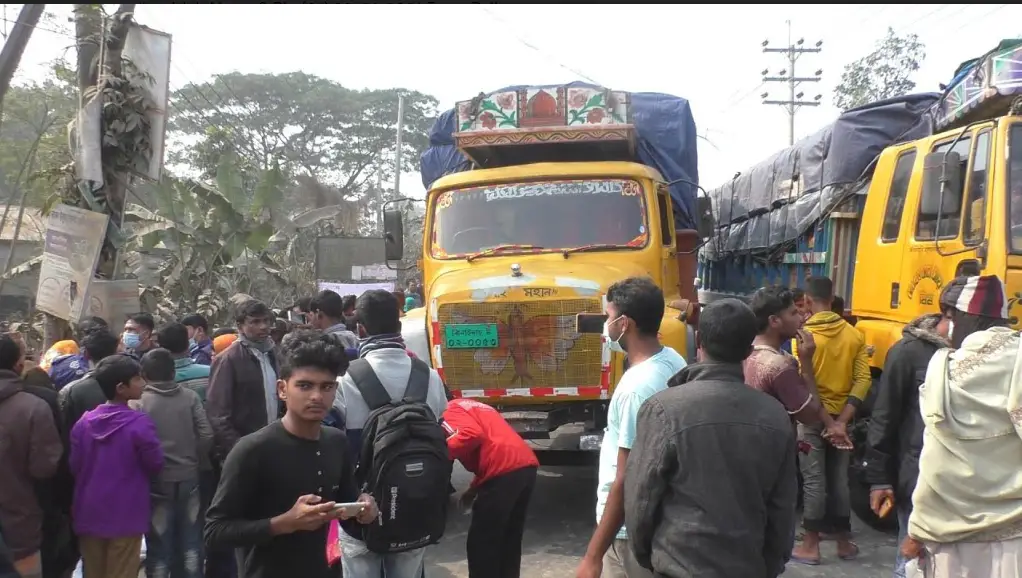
[138,382,213,482]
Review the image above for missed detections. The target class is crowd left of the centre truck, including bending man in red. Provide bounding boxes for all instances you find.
[0,286,539,578]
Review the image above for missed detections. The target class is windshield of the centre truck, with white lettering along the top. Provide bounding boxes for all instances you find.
[430,179,649,258]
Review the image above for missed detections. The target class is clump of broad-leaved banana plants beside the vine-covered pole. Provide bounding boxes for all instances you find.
[126,155,297,321]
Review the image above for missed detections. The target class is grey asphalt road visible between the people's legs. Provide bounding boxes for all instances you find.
[426,459,896,578]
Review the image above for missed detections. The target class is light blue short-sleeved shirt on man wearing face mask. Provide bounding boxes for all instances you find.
[596,347,686,540]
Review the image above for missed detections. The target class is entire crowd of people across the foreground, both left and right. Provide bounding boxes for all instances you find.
[0,276,1022,578]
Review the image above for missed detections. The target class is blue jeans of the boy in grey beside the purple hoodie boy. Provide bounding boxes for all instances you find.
[145,479,203,578]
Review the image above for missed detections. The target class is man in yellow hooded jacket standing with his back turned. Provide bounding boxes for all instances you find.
[791,277,872,566]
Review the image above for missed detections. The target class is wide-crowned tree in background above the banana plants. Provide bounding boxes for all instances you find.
[170,73,436,217]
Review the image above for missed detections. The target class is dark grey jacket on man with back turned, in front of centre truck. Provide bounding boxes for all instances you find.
[624,364,797,578]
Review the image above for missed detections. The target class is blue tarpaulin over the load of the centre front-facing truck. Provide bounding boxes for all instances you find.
[421,83,699,229]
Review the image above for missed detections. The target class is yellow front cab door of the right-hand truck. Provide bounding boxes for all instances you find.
[900,128,990,320]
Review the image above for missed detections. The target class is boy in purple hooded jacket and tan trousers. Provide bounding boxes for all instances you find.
[69,354,164,578]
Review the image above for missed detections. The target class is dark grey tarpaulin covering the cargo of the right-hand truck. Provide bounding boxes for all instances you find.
[702,93,939,260]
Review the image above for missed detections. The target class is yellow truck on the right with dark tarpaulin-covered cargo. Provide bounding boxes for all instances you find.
[699,41,1022,527]
